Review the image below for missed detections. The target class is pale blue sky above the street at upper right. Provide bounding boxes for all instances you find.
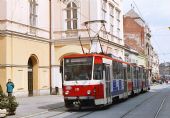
[123,0,170,63]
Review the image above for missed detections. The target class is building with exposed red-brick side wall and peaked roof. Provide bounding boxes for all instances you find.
[123,9,146,67]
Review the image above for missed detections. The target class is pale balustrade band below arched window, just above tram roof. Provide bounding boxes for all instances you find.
[53,29,125,48]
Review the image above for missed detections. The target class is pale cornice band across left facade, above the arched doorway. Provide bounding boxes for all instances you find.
[0,19,50,42]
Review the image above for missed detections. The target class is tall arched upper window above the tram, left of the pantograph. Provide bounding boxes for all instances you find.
[66,2,78,30]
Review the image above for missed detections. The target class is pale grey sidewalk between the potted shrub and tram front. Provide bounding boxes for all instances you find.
[7,95,64,118]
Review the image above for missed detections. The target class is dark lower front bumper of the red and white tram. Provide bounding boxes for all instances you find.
[64,96,95,108]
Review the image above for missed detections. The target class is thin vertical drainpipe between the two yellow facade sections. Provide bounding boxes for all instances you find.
[49,0,52,94]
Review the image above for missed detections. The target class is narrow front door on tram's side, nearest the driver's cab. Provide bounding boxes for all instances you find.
[105,65,111,103]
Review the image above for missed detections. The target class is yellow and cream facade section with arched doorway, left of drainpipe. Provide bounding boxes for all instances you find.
[0,0,50,96]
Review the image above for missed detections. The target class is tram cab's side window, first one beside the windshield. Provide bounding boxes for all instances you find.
[93,64,103,80]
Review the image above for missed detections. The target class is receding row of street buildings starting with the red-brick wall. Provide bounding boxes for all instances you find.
[124,9,159,83]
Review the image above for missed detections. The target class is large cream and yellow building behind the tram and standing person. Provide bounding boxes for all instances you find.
[0,0,125,96]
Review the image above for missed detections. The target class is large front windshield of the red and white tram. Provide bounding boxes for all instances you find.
[64,57,93,81]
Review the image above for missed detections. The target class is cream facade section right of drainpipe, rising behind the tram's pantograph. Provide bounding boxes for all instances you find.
[52,0,125,93]
